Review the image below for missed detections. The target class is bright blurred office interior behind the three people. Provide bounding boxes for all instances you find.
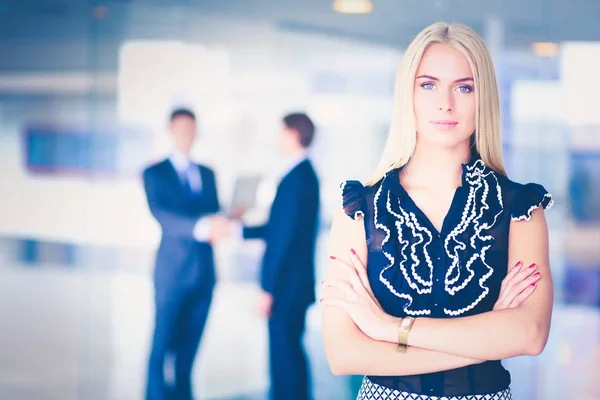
[0,0,600,400]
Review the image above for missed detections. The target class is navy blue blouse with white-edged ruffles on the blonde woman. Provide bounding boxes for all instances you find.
[342,156,553,396]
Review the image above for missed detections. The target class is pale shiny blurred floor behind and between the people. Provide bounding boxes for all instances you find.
[0,256,600,400]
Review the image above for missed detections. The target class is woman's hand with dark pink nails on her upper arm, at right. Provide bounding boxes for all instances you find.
[494,261,541,310]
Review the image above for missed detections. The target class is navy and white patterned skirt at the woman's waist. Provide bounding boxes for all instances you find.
[356,376,512,400]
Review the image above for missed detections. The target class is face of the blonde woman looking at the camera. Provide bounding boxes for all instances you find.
[413,43,475,148]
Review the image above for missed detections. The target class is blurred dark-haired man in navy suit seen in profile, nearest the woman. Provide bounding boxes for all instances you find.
[237,113,319,400]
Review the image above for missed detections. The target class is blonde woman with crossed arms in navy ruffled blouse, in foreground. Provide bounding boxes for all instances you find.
[321,23,553,400]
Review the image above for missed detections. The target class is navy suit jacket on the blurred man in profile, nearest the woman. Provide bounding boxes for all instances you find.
[244,160,319,307]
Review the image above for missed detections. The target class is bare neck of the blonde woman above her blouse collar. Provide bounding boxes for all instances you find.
[401,143,471,188]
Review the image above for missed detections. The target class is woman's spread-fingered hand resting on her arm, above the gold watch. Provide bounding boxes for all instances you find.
[321,250,401,342]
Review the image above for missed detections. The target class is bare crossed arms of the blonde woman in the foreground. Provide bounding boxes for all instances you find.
[323,205,553,376]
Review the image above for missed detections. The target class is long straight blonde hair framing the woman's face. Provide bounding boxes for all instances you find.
[367,22,506,185]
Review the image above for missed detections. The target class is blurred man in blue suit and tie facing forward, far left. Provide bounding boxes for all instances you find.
[143,109,229,400]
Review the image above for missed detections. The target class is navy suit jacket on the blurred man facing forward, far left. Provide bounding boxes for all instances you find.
[143,160,219,296]
